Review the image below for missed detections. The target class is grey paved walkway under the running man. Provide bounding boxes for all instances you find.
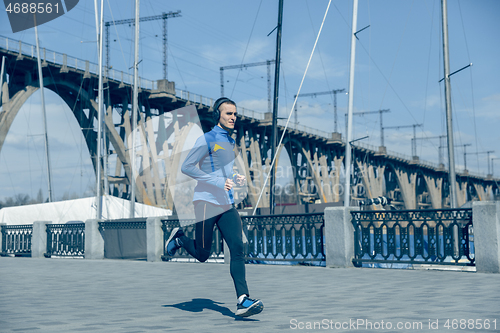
[0,258,500,333]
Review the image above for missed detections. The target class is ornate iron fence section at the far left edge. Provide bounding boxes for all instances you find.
[0,225,33,256]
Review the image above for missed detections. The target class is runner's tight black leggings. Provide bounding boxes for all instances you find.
[180,201,250,297]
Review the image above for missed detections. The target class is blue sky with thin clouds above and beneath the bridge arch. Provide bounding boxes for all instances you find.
[0,0,500,200]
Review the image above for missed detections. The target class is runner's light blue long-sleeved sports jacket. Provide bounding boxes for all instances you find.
[181,126,236,205]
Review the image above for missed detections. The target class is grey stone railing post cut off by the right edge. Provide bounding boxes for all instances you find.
[472,201,500,273]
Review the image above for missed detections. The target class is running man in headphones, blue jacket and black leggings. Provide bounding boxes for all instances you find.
[166,97,264,317]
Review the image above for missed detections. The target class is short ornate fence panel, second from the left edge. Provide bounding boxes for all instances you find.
[44,223,85,258]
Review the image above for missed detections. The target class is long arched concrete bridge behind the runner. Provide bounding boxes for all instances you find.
[0,36,500,209]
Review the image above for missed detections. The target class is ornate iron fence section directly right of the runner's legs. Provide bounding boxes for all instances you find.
[242,213,325,265]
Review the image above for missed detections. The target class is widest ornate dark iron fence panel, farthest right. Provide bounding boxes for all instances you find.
[351,209,474,266]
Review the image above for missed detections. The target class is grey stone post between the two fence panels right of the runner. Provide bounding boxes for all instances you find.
[324,207,358,267]
